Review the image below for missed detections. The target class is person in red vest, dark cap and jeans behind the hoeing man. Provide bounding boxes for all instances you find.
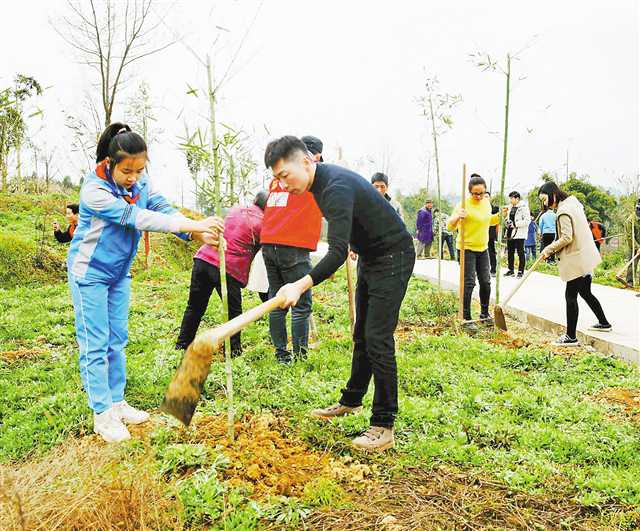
[260,136,322,365]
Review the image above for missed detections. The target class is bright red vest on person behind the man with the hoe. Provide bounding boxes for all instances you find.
[260,179,322,251]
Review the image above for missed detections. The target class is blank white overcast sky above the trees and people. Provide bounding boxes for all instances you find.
[0,0,639,206]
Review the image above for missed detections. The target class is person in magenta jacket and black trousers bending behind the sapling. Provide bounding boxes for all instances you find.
[176,191,268,356]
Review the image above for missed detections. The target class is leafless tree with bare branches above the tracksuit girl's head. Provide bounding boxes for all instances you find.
[53,0,175,126]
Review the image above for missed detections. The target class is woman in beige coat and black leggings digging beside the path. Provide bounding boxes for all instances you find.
[538,182,611,347]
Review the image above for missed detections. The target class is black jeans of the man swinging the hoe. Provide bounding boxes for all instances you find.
[340,248,416,428]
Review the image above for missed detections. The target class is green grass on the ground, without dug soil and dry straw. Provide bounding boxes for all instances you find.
[0,264,640,529]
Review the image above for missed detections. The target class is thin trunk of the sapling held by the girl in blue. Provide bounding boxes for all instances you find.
[207,55,234,441]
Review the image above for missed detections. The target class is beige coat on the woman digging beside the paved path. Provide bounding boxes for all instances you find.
[548,196,602,282]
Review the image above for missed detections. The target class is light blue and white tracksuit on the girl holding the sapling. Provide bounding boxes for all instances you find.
[67,165,188,413]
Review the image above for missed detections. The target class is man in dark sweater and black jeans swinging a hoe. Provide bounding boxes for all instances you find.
[265,136,415,450]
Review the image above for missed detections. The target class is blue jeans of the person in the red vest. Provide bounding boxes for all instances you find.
[262,244,312,358]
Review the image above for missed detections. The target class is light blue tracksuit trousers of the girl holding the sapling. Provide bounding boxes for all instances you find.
[69,273,131,413]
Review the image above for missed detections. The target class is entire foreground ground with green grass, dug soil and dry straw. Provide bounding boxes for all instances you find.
[0,194,640,530]
